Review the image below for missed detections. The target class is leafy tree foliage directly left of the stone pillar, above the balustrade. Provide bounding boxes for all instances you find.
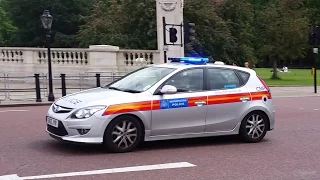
[78,0,157,49]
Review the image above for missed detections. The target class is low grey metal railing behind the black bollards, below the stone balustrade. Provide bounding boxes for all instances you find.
[0,72,127,103]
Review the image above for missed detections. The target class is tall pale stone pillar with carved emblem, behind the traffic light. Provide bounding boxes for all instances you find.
[156,0,184,63]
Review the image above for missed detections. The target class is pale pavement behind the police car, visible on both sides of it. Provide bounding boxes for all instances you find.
[0,86,320,107]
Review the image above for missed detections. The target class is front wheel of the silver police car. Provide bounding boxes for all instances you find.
[103,115,142,153]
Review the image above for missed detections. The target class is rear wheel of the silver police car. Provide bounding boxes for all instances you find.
[239,111,269,143]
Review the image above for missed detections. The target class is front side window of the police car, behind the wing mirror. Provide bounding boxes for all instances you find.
[164,68,204,92]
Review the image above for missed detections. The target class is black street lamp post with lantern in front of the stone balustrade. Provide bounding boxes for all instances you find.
[41,10,54,101]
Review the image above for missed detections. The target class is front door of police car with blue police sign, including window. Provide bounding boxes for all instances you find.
[151,68,207,136]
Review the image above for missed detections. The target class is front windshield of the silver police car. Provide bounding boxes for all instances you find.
[105,66,175,93]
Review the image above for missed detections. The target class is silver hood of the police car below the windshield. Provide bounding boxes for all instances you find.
[55,88,137,108]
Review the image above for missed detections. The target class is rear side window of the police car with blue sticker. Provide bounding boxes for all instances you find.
[208,68,241,90]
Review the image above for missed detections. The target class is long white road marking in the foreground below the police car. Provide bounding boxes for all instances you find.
[0,162,196,180]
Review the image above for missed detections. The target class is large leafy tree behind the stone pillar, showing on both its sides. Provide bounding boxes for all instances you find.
[78,0,236,61]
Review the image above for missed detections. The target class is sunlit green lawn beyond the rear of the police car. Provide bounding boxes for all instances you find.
[255,68,320,86]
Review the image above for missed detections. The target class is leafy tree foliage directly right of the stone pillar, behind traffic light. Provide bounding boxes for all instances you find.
[184,0,237,62]
